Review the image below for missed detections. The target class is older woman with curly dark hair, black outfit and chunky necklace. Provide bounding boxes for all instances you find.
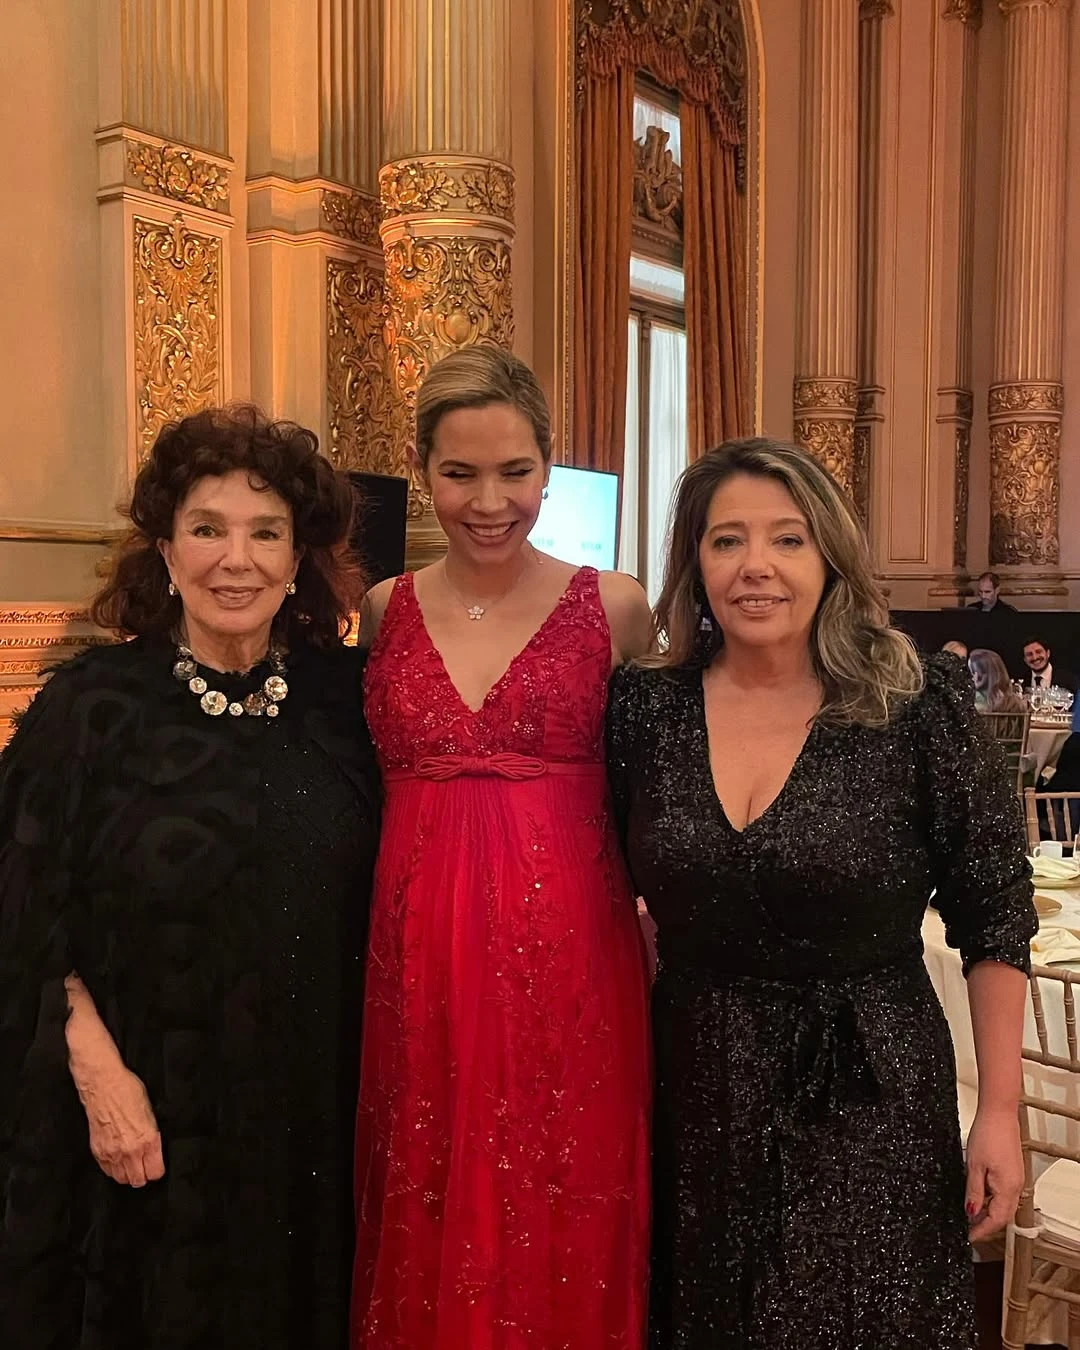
[0,406,378,1350]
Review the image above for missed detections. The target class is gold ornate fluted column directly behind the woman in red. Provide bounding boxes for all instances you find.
[379,0,514,566]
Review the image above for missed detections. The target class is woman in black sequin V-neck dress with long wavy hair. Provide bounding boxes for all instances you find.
[609,441,1035,1350]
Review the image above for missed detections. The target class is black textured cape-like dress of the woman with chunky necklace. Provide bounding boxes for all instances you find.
[0,641,378,1350]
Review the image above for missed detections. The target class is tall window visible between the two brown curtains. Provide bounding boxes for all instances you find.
[618,78,687,601]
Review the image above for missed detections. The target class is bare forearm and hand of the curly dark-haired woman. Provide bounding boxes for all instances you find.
[63,973,165,1187]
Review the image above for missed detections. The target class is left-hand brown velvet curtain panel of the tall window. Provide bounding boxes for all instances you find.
[570,68,635,474]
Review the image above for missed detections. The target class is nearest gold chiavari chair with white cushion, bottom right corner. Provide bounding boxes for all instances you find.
[1002,965,1080,1350]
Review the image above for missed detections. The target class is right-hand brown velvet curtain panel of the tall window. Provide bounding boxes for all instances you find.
[680,100,751,460]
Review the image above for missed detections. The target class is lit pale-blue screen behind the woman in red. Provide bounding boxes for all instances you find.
[529,464,618,571]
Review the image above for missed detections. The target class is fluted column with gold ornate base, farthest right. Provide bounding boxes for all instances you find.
[990,0,1071,597]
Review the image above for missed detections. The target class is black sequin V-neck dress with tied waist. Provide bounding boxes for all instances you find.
[609,657,1035,1350]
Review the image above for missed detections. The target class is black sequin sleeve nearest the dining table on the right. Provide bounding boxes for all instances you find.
[915,656,1038,973]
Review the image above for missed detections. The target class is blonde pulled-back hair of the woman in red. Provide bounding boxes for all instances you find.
[416,344,551,473]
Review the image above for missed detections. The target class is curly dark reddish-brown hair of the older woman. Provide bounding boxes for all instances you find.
[90,404,363,647]
